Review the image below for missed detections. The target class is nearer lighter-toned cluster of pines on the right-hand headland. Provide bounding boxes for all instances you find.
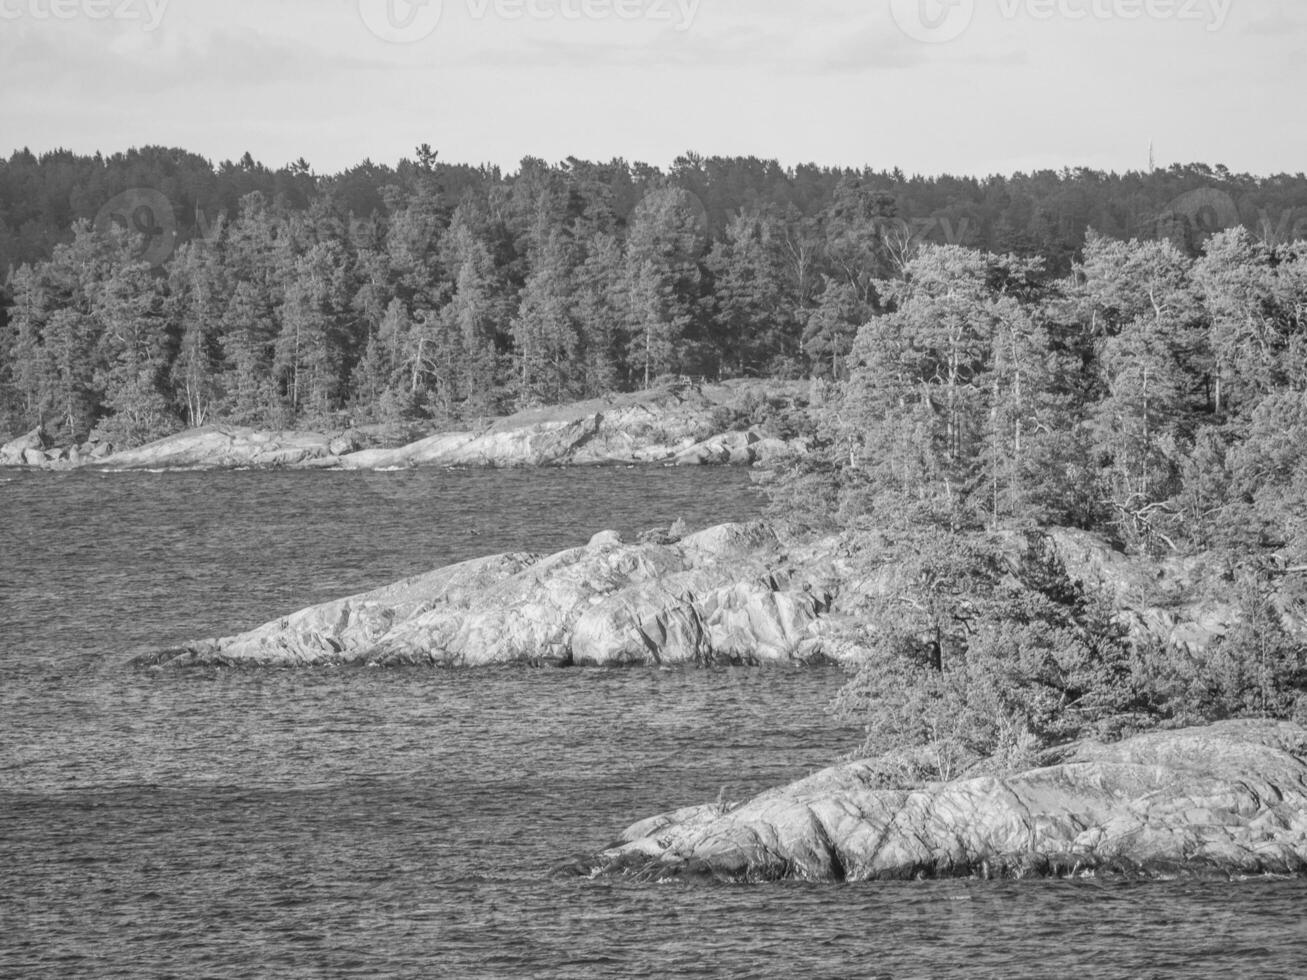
[770,229,1307,775]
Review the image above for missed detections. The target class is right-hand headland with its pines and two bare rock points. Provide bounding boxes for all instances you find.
[124,222,1307,879]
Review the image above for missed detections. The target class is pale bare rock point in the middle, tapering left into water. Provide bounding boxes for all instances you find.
[137,524,830,666]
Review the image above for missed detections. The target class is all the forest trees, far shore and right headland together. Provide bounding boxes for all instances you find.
[0,146,1307,781]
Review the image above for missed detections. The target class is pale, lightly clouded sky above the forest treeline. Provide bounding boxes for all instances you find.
[0,0,1307,175]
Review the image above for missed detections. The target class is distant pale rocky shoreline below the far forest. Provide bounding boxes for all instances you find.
[0,382,806,469]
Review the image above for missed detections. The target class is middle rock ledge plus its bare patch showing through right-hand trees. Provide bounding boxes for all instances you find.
[135,521,1254,666]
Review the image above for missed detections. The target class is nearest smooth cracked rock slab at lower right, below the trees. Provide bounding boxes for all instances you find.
[576,723,1307,881]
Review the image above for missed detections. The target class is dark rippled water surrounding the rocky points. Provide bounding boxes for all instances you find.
[0,469,1307,980]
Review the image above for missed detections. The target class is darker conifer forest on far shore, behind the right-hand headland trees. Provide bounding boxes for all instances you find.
[0,146,1307,444]
